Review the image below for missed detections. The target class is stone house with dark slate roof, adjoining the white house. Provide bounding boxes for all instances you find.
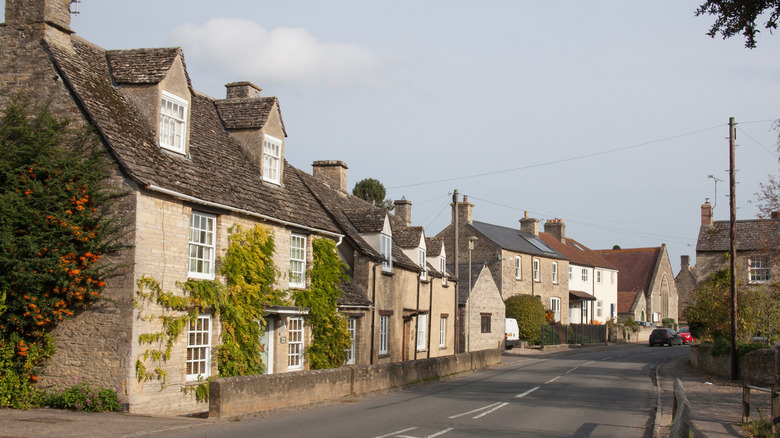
[437,198,569,324]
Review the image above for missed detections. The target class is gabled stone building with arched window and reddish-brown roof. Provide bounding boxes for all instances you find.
[596,244,678,323]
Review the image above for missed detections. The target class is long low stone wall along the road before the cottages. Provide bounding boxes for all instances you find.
[209,349,501,419]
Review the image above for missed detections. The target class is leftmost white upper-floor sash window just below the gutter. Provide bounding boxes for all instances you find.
[187,210,217,280]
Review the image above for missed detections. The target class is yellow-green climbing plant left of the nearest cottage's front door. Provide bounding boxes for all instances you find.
[135,225,290,401]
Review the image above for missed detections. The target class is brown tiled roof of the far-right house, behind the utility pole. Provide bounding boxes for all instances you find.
[696,219,780,252]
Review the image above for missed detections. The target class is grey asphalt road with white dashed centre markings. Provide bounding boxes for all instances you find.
[154,345,689,438]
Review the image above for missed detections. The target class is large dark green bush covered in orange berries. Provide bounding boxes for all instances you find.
[0,102,122,407]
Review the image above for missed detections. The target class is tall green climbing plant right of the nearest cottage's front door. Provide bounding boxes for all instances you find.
[292,239,350,369]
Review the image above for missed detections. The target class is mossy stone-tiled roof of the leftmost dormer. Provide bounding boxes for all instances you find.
[106,47,192,86]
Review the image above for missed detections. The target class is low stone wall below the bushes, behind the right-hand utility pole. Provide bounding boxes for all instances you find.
[691,344,778,385]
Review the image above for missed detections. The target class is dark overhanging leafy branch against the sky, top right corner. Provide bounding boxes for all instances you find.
[696,0,780,49]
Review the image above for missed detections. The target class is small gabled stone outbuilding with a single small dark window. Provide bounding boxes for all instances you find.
[458,263,506,351]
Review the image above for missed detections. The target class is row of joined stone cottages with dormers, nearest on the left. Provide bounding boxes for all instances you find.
[0,0,456,415]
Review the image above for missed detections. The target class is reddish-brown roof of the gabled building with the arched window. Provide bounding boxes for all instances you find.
[596,247,662,313]
